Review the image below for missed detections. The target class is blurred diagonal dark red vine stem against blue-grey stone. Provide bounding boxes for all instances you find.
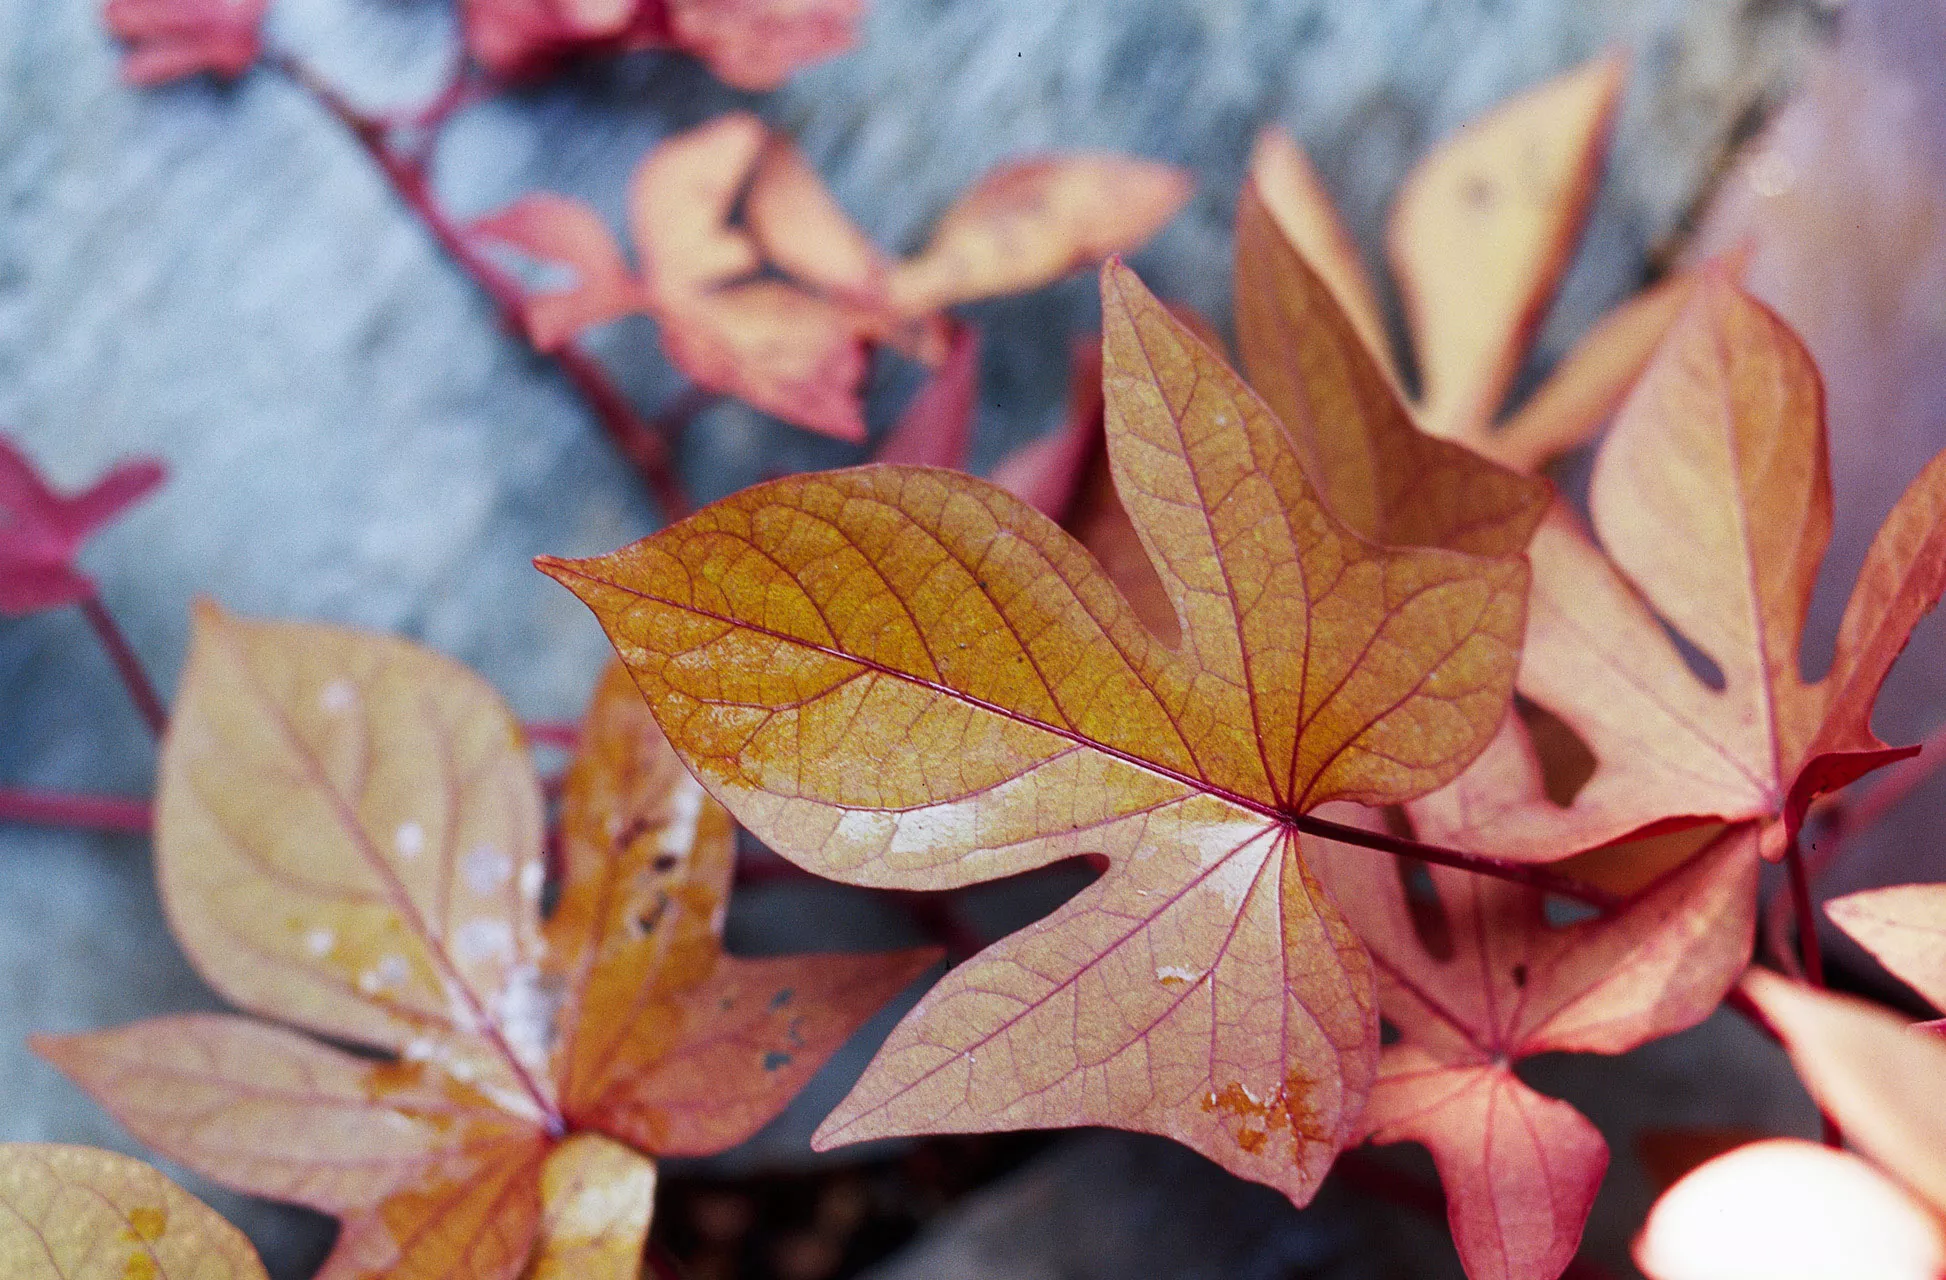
[263,51,714,521]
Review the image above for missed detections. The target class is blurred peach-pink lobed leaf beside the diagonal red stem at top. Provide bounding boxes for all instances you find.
[484,121,1189,444]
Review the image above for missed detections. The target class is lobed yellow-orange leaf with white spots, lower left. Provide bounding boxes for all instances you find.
[35,605,934,1280]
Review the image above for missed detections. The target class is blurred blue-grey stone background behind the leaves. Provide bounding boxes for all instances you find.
[0,0,1946,1280]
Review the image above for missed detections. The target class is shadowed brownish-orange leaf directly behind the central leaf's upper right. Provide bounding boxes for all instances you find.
[1236,181,1549,556]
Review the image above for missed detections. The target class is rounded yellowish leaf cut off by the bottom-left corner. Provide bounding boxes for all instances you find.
[0,1142,267,1280]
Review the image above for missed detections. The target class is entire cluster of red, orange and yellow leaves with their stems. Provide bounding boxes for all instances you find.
[11,0,1946,1280]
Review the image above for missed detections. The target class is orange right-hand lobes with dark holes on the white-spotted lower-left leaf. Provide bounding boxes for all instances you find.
[549,663,938,1156]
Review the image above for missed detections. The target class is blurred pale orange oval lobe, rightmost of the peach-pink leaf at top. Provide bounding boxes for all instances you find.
[891,156,1193,315]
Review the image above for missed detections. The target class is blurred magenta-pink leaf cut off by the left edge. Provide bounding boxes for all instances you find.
[0,436,165,617]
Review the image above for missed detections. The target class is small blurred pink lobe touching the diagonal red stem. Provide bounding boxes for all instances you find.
[469,193,644,350]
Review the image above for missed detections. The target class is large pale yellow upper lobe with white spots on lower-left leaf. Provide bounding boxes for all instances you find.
[156,603,553,1119]
